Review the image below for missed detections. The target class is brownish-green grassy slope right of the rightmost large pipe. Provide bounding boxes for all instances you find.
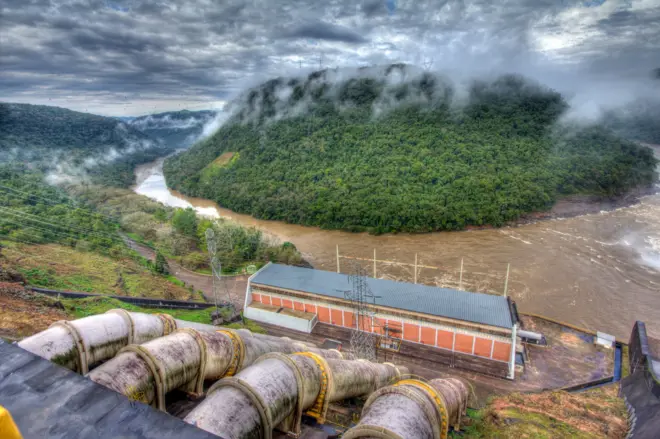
[453,385,627,439]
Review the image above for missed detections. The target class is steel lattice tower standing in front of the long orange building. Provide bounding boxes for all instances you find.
[344,264,376,361]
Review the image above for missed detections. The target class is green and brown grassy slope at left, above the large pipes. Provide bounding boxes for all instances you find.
[2,241,199,300]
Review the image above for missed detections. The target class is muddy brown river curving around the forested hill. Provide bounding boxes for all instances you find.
[134,159,660,341]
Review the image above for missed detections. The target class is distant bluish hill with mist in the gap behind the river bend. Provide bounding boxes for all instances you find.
[127,110,216,148]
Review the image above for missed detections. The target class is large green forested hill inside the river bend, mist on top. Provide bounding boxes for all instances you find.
[165,65,657,233]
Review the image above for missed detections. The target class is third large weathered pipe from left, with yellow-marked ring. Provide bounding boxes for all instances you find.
[184,352,408,439]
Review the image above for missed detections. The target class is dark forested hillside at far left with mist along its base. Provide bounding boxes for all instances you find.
[0,103,173,186]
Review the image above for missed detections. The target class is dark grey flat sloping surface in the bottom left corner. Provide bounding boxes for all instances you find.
[0,340,218,439]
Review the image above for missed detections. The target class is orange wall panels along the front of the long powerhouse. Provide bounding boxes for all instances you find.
[248,287,511,362]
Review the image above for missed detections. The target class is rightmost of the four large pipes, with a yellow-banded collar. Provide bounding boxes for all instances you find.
[343,378,470,439]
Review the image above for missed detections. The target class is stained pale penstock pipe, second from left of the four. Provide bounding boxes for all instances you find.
[87,327,341,410]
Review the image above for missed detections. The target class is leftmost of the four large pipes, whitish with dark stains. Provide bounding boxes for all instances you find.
[18,309,240,374]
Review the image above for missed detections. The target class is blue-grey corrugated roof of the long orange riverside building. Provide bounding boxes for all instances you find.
[252,264,513,328]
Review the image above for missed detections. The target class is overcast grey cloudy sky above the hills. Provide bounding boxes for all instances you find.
[0,0,660,115]
